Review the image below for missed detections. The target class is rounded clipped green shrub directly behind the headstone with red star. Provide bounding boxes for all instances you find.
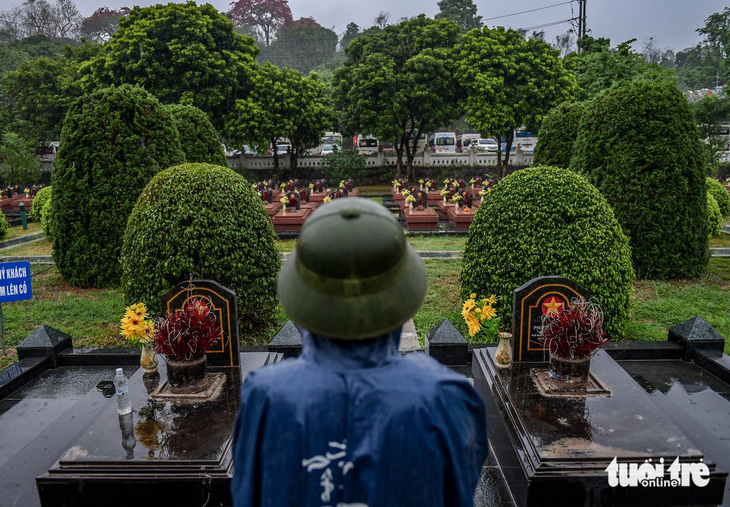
[460,166,634,339]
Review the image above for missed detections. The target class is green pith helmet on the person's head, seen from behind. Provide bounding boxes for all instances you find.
[279,197,427,340]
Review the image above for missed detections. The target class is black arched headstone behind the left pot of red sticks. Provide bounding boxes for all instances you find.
[162,280,241,367]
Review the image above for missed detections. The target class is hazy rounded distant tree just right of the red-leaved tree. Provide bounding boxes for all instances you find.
[259,25,337,74]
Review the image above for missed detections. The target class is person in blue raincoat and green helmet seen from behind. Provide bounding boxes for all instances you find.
[231,198,488,507]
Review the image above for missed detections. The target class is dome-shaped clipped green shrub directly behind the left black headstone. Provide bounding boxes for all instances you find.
[121,164,279,336]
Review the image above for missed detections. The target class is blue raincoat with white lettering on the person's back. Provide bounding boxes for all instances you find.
[231,330,488,507]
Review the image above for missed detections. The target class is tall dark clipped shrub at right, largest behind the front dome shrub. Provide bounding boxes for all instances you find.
[570,81,709,279]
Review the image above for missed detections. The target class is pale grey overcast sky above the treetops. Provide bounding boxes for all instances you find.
[65,0,729,51]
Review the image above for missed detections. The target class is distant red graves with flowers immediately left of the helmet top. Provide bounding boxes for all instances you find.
[253,178,360,232]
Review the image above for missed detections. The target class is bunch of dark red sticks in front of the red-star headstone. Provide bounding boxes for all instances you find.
[541,298,610,359]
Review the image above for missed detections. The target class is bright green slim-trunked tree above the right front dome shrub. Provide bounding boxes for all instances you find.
[455,27,577,176]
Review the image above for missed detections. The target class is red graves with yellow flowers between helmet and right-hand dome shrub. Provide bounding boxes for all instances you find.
[392,176,494,230]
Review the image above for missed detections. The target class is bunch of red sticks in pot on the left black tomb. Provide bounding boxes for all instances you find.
[154,299,221,361]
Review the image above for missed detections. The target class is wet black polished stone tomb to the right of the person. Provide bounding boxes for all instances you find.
[472,348,727,505]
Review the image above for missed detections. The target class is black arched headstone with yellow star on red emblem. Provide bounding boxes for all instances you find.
[512,276,591,362]
